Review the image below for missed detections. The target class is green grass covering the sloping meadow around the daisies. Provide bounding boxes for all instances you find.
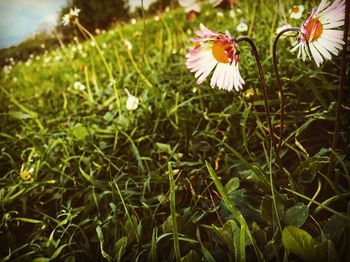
[0,1,350,261]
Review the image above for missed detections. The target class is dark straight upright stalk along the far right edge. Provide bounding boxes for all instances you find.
[327,0,350,177]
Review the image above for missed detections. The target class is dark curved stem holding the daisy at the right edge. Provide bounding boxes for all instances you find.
[272,27,300,154]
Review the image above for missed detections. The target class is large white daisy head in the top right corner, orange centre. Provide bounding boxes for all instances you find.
[292,0,345,67]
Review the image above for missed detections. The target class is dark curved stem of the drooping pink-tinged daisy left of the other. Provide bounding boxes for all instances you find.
[235,36,283,170]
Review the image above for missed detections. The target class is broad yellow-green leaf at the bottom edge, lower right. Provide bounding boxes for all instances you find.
[282,226,318,262]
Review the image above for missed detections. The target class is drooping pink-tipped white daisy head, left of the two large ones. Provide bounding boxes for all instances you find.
[186,24,244,91]
